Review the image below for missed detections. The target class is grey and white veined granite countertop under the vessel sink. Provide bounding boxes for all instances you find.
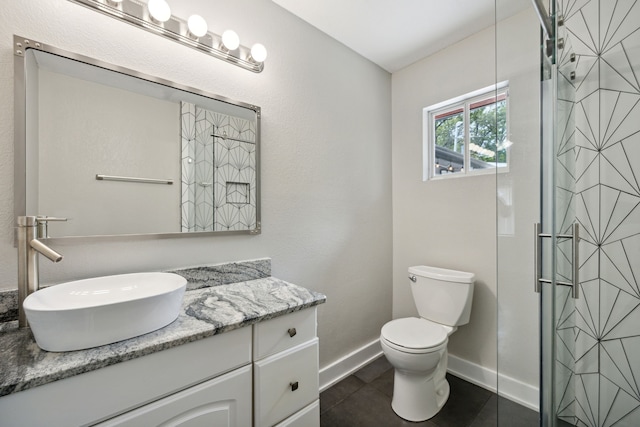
[0,260,326,396]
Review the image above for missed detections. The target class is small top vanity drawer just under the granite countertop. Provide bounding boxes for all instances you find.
[253,307,317,360]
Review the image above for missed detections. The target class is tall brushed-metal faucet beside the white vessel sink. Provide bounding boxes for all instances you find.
[18,216,66,328]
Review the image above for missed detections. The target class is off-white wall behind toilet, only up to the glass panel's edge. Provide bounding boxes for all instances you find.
[392,23,496,374]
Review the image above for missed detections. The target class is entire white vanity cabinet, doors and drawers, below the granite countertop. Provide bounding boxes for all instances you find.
[0,307,320,427]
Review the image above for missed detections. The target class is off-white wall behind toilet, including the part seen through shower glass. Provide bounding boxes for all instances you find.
[392,11,539,402]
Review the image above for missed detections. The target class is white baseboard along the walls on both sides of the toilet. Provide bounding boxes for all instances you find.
[320,339,539,411]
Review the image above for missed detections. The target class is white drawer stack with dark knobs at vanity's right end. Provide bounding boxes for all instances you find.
[253,308,320,427]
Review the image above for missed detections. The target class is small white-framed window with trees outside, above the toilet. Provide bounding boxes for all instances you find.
[424,82,511,180]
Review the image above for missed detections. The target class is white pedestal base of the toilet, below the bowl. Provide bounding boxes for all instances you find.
[391,369,449,422]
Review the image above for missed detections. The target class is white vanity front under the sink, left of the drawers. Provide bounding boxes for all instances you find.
[0,327,252,427]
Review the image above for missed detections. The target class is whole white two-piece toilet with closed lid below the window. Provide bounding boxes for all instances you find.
[380,265,475,422]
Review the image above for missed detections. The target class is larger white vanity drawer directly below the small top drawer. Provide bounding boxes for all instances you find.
[253,338,319,427]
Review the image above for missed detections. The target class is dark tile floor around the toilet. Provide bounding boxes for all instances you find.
[320,356,539,427]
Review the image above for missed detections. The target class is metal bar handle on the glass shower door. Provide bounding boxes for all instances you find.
[533,222,580,299]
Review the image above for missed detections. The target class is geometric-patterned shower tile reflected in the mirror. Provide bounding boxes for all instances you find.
[181,102,256,231]
